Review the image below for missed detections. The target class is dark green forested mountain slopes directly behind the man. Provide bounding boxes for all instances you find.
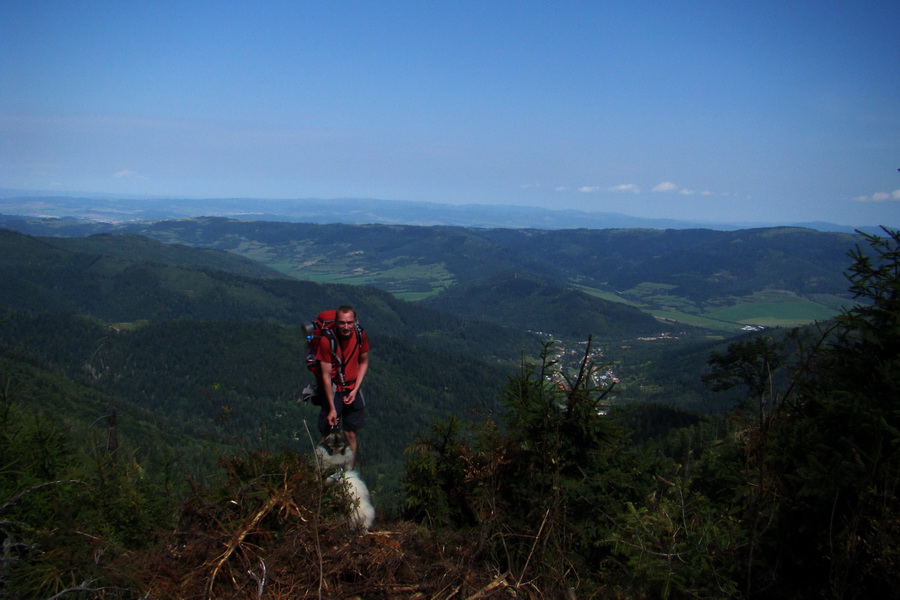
[0,231,539,501]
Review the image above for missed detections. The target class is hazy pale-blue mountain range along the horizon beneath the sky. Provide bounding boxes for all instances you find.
[0,188,879,233]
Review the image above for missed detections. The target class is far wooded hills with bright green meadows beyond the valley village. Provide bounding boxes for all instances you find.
[0,218,858,337]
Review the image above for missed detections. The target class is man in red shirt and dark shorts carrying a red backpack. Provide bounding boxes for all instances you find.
[316,306,369,469]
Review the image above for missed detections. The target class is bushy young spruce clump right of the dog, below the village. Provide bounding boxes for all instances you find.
[406,341,659,595]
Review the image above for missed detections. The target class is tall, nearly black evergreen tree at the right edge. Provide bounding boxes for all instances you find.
[778,229,900,598]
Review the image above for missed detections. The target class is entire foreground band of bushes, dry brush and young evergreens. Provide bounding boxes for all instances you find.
[0,231,900,599]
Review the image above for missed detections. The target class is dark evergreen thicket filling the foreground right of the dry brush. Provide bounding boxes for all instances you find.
[408,227,900,598]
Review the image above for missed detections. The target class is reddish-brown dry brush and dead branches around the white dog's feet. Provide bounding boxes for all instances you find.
[128,457,540,600]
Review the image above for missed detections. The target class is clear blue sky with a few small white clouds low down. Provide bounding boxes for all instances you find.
[0,0,900,227]
